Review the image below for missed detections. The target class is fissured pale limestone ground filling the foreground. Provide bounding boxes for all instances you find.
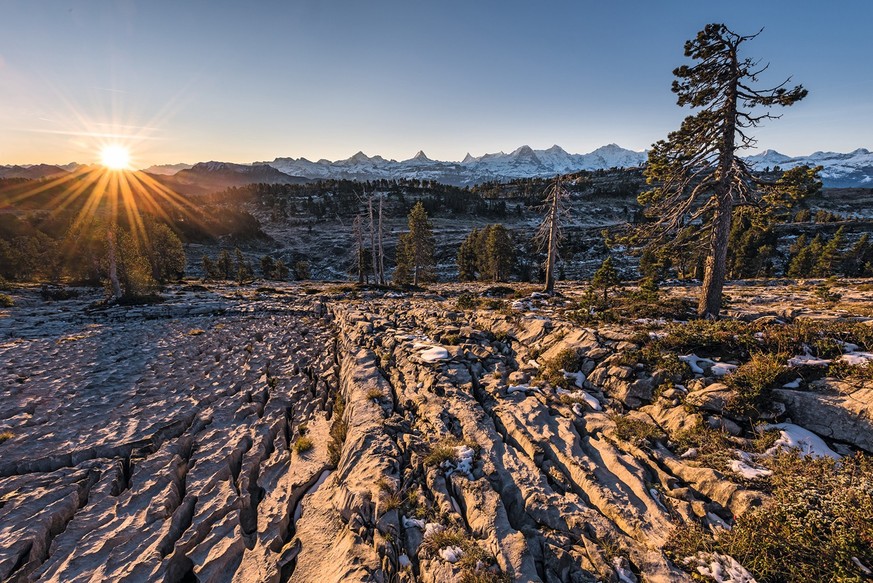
[0,282,873,582]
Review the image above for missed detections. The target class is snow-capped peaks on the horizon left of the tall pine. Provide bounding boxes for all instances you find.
[260,144,646,185]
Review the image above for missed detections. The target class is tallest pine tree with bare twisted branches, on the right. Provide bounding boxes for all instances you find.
[639,24,807,318]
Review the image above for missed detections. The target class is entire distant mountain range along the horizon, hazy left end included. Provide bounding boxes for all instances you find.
[0,144,873,192]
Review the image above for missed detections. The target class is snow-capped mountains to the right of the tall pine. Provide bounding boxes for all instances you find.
[746,148,873,188]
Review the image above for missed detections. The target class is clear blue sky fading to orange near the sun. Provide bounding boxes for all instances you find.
[0,0,873,167]
